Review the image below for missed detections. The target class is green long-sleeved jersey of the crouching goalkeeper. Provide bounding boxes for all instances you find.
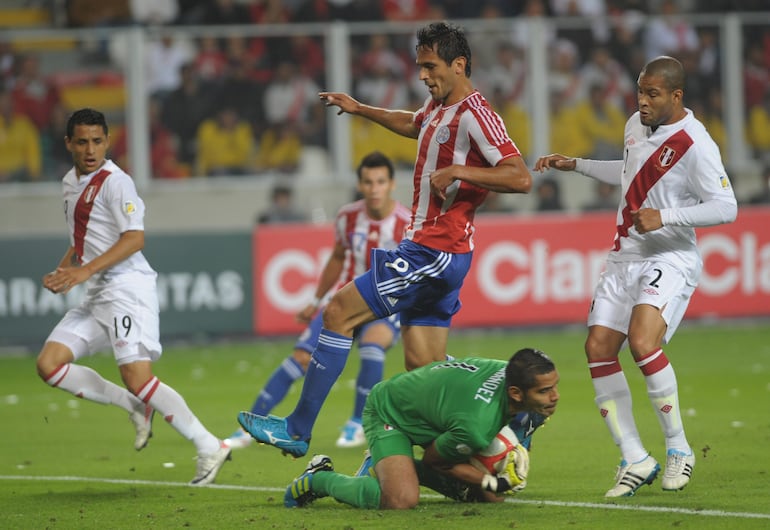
[366,357,511,462]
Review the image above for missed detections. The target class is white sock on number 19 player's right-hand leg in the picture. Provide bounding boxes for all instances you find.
[137,377,220,455]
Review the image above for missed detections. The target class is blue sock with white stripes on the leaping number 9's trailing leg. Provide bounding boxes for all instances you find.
[286,328,353,440]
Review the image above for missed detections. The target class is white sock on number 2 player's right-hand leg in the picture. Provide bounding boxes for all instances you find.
[636,349,692,453]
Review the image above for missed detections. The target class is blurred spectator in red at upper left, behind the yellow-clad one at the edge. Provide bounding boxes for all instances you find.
[11,53,61,133]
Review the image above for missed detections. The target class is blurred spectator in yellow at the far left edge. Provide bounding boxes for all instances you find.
[0,87,42,182]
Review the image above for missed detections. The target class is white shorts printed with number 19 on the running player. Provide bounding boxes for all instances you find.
[46,278,162,366]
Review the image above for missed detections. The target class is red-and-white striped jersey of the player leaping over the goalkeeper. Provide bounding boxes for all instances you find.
[406,91,521,253]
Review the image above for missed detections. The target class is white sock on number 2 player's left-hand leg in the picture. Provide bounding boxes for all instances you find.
[588,357,649,464]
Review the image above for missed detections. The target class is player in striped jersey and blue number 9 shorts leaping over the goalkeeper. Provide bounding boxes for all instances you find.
[238,22,532,456]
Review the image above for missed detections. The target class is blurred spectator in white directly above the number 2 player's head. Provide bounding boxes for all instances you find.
[644,0,700,60]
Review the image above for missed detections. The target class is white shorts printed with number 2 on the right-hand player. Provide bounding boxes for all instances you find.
[588,261,695,343]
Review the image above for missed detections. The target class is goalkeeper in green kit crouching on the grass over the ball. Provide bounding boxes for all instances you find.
[284,348,559,509]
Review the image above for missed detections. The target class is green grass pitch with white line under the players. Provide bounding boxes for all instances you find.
[0,323,770,530]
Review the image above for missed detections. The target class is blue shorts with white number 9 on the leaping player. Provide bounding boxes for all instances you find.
[354,239,473,327]
